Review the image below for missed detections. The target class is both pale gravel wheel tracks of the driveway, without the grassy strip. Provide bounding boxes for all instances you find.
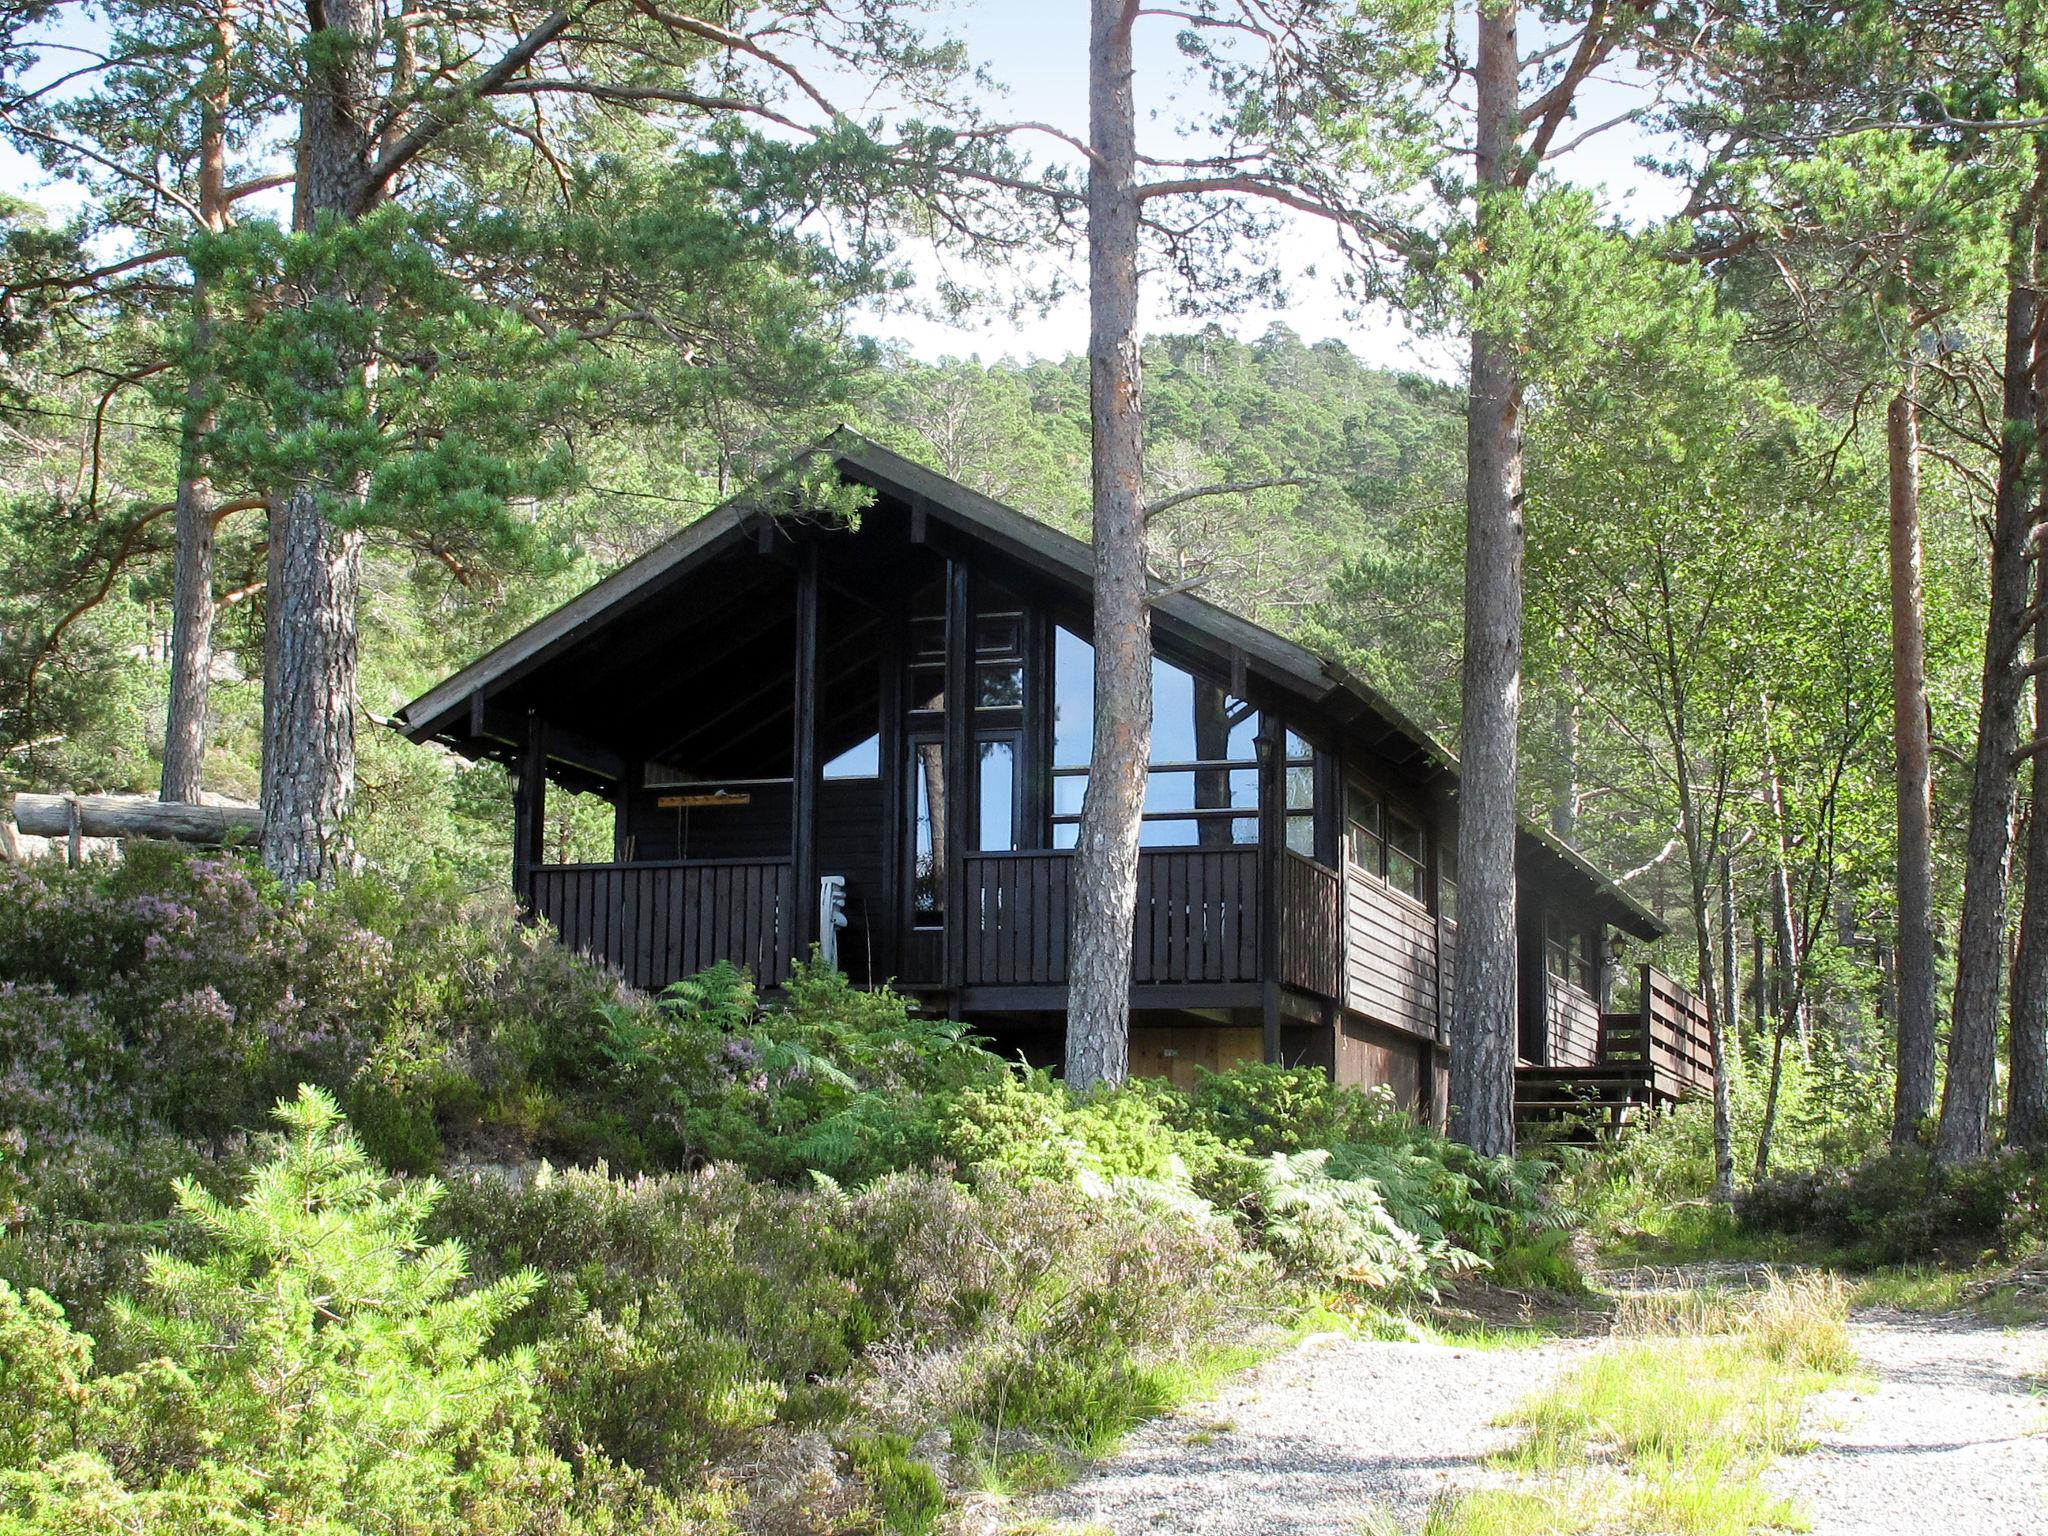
[1015,1313,2048,1536]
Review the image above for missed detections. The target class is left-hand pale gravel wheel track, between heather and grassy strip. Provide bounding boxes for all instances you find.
[1019,1333,1597,1536]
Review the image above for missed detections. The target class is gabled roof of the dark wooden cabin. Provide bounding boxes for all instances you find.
[397,426,1665,938]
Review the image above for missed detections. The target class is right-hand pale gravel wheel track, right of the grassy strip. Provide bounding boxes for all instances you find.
[1769,1311,2048,1536]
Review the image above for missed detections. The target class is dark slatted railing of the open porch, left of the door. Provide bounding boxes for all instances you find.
[526,858,795,989]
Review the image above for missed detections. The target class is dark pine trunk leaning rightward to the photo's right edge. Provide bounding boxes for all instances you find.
[1933,153,2048,1165]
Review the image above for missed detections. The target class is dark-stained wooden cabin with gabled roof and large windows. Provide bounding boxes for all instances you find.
[399,430,1698,1112]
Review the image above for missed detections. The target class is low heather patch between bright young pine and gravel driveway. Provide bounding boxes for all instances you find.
[436,1165,1272,1483]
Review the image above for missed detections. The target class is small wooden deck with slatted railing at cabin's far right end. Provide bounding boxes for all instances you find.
[1516,965,1714,1126]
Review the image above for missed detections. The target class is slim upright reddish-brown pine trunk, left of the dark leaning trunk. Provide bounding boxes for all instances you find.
[1884,371,1935,1147]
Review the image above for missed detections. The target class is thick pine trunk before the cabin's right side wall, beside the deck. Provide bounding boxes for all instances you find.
[1450,0,1522,1155]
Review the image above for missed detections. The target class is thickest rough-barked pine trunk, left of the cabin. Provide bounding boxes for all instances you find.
[262,0,379,885]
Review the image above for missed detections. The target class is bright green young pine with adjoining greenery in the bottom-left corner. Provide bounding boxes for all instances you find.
[0,1090,712,1536]
